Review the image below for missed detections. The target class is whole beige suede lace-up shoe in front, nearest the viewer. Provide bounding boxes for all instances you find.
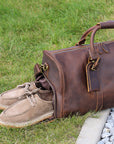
[0,89,54,128]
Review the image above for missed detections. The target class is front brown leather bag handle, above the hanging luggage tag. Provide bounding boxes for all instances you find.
[90,21,114,59]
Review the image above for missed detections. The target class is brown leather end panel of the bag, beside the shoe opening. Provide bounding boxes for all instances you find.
[42,51,64,117]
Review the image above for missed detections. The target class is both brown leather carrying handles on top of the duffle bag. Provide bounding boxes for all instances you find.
[76,21,114,59]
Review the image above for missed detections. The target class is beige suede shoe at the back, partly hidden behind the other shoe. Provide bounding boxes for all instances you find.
[0,82,37,109]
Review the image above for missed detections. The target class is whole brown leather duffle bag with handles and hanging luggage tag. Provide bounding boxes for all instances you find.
[34,21,114,118]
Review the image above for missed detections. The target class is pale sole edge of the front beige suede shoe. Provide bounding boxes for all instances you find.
[0,111,54,128]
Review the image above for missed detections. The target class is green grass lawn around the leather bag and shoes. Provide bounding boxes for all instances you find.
[0,0,114,144]
